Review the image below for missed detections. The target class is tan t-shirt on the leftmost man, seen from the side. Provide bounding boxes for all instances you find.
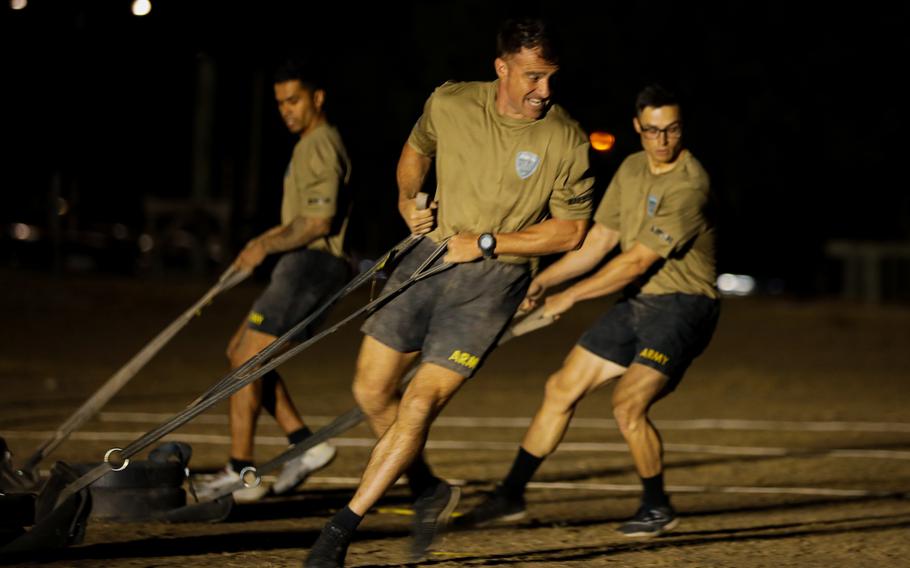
[281,123,351,258]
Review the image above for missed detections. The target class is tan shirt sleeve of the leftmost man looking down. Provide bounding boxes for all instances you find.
[293,138,345,218]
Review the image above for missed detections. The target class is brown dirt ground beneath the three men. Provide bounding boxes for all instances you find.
[0,271,910,568]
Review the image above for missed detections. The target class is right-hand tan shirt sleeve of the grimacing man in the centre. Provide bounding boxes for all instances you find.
[550,129,594,220]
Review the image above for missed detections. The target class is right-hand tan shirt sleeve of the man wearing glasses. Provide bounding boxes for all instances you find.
[636,184,708,258]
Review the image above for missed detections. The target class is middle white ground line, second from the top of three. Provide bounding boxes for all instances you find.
[3,430,910,460]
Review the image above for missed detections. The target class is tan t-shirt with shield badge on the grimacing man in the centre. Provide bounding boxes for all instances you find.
[408,81,594,262]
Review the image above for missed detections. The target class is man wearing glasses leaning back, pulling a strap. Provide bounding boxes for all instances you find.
[456,85,719,536]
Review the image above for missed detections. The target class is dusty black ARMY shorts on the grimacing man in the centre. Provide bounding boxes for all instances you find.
[361,238,530,377]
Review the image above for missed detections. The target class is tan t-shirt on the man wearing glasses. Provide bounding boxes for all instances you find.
[594,151,718,298]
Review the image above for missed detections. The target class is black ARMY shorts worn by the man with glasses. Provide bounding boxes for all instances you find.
[578,294,720,390]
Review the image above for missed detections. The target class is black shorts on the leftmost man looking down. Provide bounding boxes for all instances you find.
[247,249,351,341]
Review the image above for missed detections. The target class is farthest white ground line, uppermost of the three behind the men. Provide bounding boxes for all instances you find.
[99,412,910,433]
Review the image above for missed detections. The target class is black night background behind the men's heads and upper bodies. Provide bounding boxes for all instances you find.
[0,0,910,296]
